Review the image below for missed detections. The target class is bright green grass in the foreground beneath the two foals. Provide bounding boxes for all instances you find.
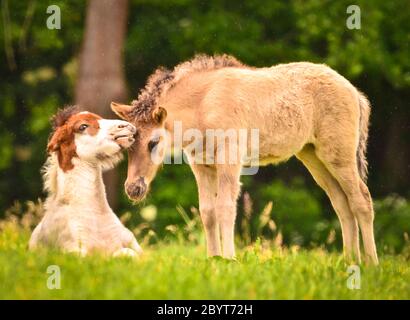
[0,228,410,299]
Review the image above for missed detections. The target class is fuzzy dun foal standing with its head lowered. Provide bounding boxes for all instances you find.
[111,55,378,264]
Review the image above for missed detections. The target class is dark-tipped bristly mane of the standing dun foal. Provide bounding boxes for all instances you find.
[131,54,246,120]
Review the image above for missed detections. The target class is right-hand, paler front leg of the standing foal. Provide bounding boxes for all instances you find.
[215,165,241,259]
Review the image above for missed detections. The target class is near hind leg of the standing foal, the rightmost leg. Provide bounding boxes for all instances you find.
[316,148,378,265]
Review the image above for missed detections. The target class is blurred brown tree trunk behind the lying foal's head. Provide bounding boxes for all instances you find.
[75,0,128,208]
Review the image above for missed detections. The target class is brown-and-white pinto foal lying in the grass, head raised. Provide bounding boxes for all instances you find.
[29,107,142,256]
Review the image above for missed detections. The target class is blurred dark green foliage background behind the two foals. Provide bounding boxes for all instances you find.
[0,0,410,252]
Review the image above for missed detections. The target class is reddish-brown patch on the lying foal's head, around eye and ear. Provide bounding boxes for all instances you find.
[47,109,102,172]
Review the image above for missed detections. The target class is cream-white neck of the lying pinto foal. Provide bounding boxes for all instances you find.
[49,159,111,214]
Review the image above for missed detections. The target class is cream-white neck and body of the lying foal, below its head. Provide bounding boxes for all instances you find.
[29,156,142,256]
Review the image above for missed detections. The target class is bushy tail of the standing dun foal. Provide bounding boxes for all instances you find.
[356,92,370,182]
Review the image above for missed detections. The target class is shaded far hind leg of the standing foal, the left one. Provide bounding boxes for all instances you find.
[296,146,360,263]
